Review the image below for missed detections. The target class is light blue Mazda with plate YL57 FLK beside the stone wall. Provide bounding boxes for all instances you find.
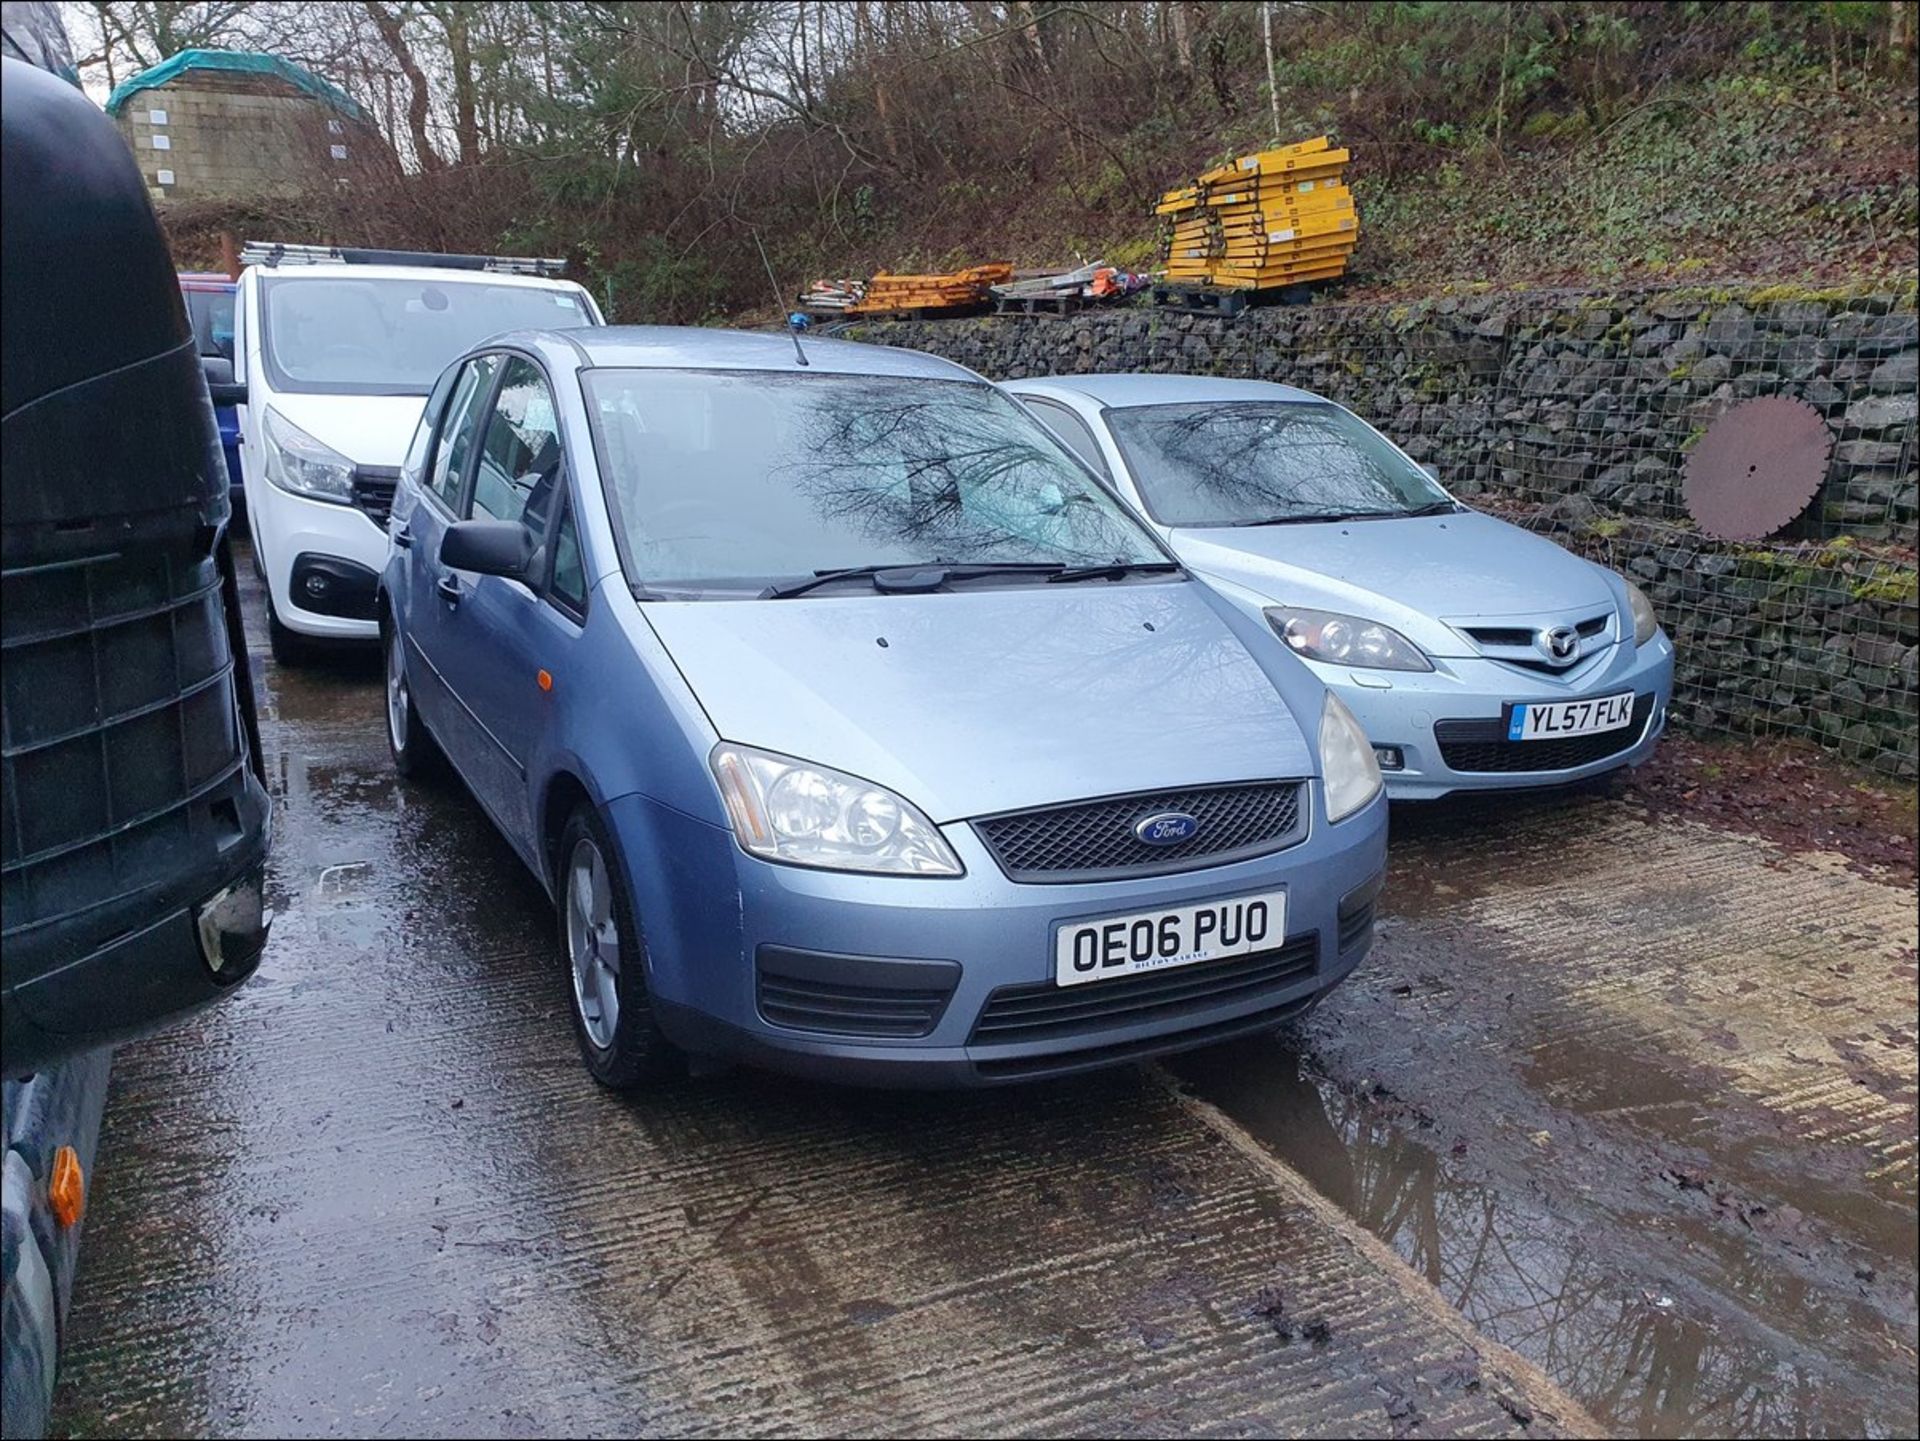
[1006,374,1674,800]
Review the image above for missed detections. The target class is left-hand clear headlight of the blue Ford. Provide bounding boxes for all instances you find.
[710,743,966,875]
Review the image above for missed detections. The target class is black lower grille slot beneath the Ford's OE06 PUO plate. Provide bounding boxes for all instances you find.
[970,931,1319,1046]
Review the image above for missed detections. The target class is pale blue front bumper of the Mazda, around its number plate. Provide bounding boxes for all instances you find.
[1308,631,1674,800]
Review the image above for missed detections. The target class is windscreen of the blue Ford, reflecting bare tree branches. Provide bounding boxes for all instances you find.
[584,370,1167,589]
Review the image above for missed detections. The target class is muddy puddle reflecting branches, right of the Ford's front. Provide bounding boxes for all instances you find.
[1169,1042,1914,1437]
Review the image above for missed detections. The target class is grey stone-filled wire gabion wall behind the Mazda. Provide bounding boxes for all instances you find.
[847,290,1920,777]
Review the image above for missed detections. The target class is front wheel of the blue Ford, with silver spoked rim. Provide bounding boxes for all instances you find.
[553,804,685,1090]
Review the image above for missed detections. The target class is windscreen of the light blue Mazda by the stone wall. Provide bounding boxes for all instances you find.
[1106,401,1448,526]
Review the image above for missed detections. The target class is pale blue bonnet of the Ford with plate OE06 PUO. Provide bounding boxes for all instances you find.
[645,581,1313,823]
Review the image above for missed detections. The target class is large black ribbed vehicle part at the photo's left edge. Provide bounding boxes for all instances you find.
[0,59,271,1078]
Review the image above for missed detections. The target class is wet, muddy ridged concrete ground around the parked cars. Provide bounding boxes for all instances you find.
[45,567,1916,1435]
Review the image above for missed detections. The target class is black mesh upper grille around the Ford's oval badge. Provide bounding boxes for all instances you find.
[973,781,1308,885]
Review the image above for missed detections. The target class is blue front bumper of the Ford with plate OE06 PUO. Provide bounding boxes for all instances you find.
[607,783,1386,1086]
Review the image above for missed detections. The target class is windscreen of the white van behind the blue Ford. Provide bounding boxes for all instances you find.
[261,274,593,395]
